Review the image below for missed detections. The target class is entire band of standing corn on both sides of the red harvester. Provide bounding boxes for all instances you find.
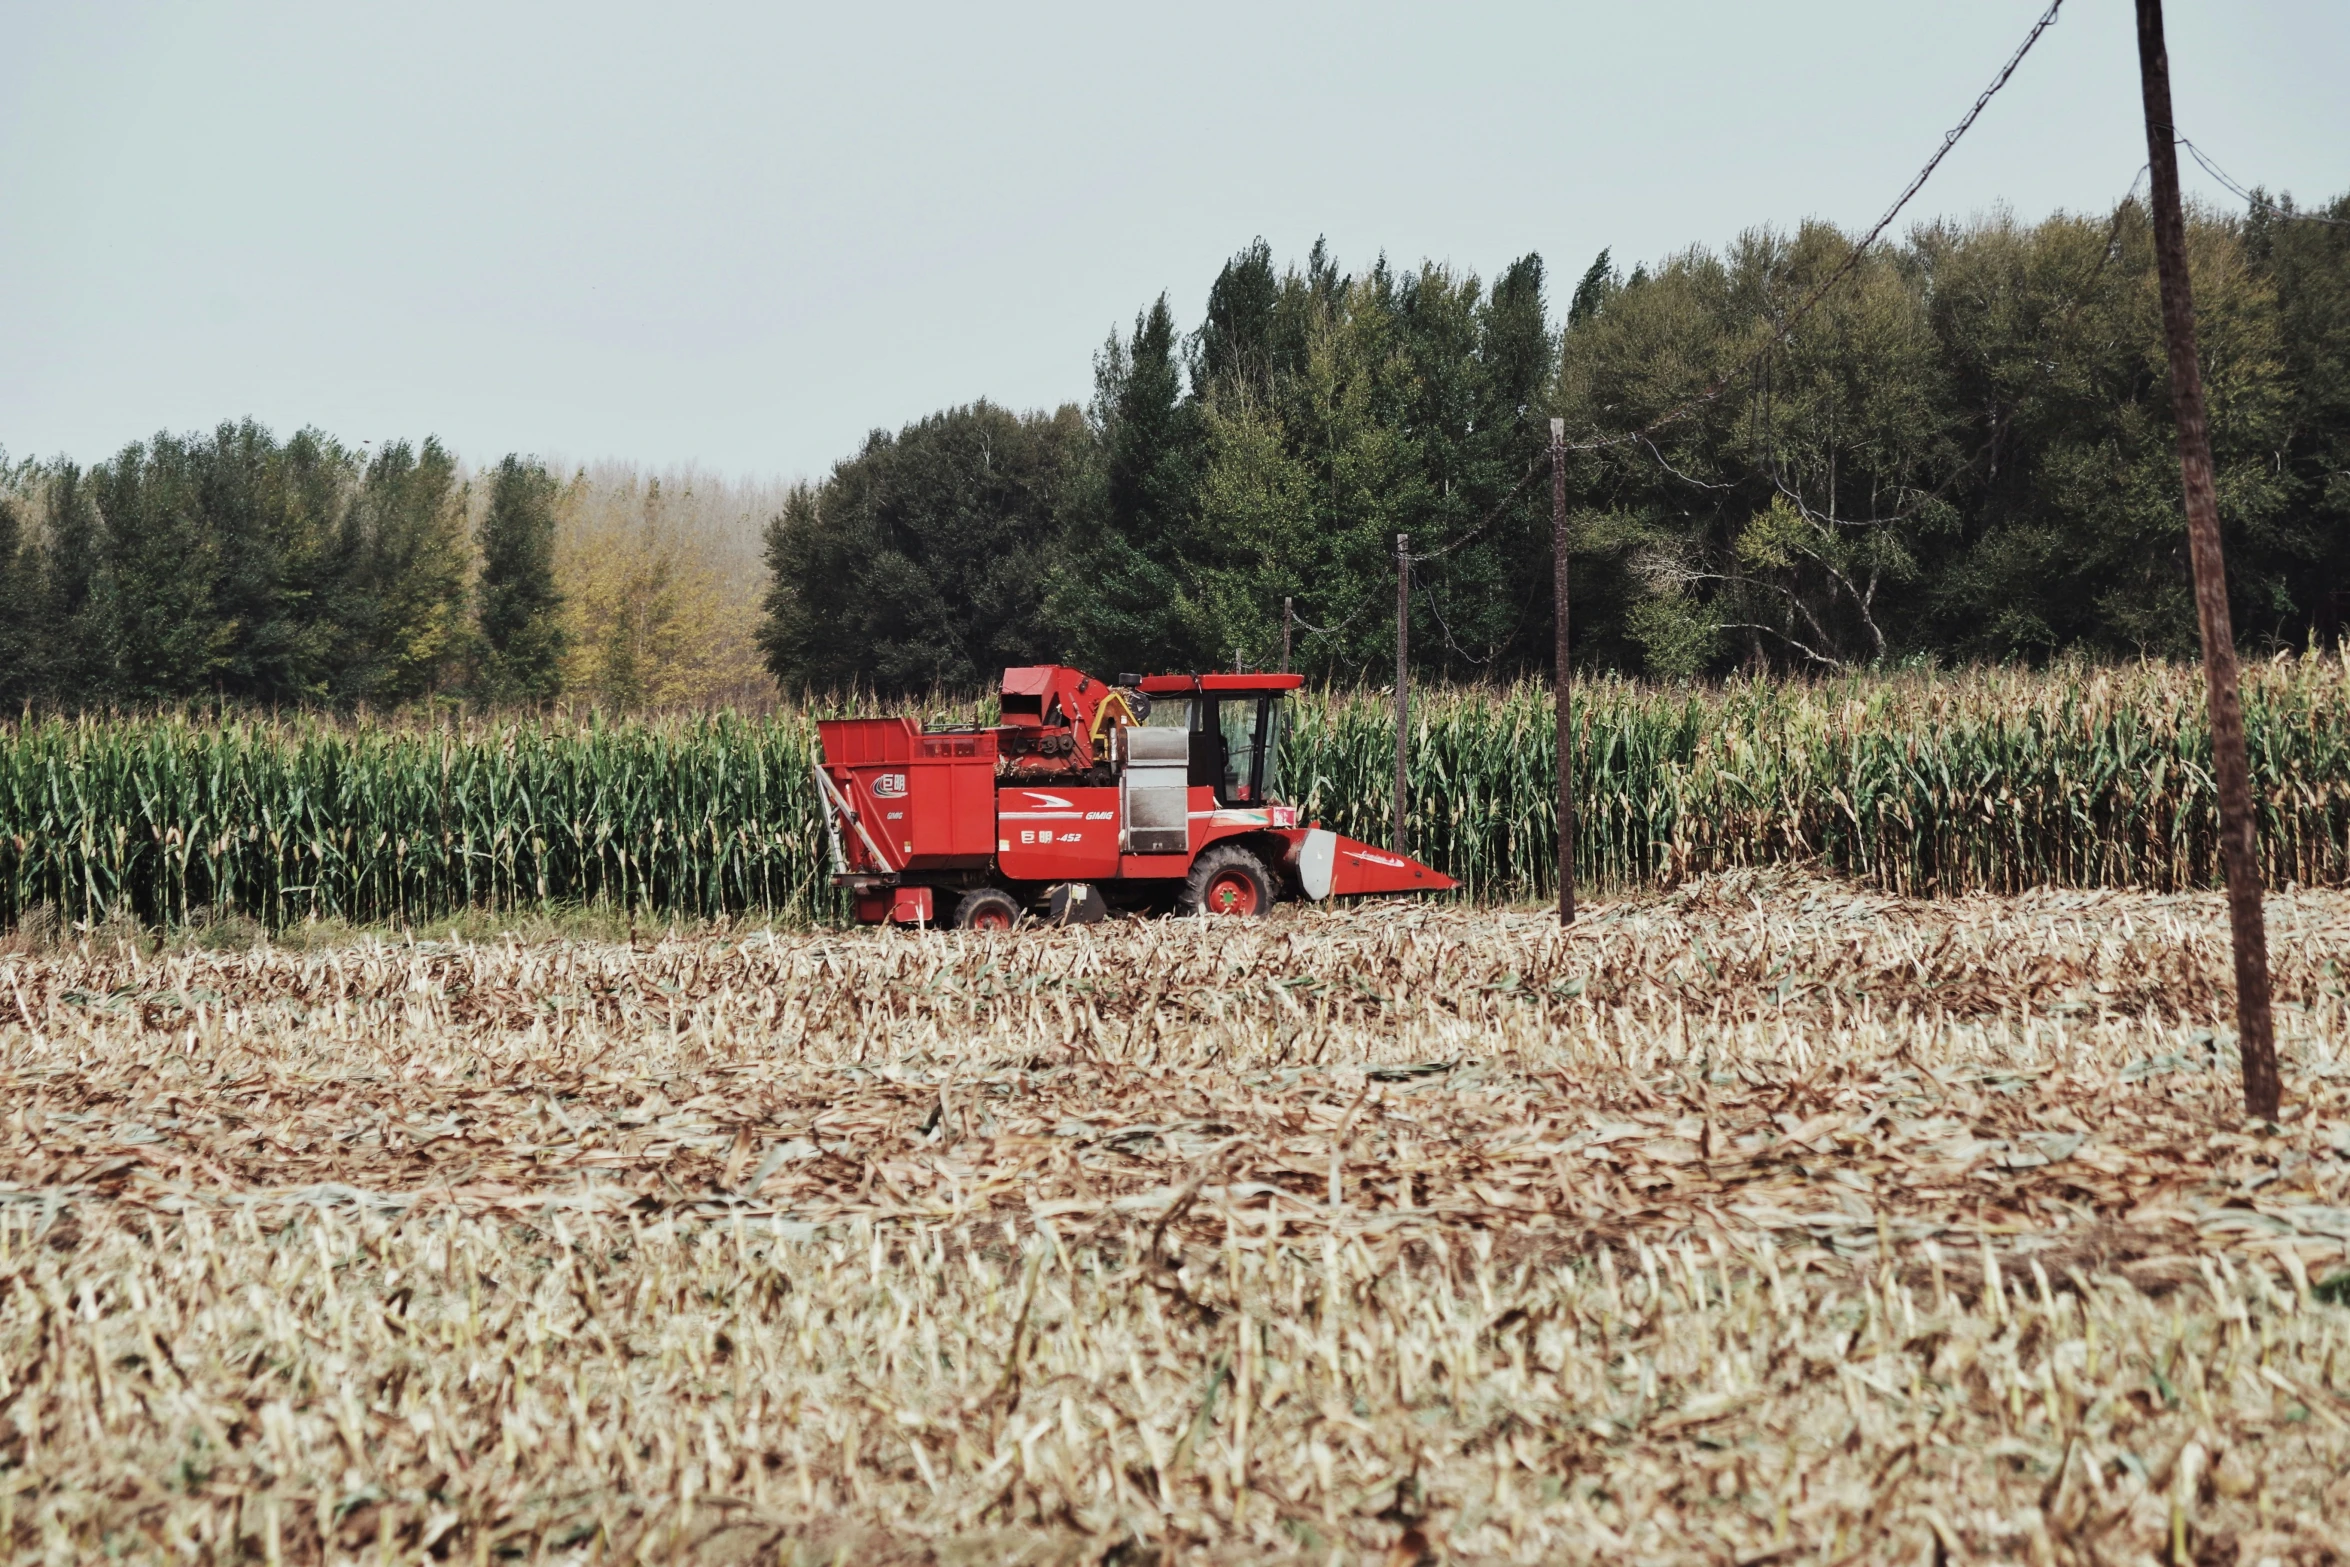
[0,653,2350,926]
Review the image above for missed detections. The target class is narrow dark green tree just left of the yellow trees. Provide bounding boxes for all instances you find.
[472,453,566,707]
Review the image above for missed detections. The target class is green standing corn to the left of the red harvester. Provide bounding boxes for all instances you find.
[0,719,832,926]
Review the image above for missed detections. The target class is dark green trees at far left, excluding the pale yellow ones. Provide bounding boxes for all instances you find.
[0,432,564,707]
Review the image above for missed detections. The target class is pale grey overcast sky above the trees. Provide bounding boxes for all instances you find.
[0,0,2350,477]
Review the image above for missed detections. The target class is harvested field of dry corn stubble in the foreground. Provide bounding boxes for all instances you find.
[0,876,2350,1567]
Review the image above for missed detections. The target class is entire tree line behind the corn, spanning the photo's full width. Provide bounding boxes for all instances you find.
[0,197,2350,709]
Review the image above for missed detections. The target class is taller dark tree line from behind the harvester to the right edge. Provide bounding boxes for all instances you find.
[761,197,2350,691]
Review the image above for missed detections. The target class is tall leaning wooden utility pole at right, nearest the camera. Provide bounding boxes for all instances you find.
[2139,0,2284,1121]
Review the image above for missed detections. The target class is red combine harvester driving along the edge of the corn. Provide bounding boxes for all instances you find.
[815,665,1452,930]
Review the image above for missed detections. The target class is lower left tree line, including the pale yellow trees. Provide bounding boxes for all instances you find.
[0,439,783,712]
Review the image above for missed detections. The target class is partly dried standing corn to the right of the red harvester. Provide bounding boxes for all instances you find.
[1283,648,2350,897]
